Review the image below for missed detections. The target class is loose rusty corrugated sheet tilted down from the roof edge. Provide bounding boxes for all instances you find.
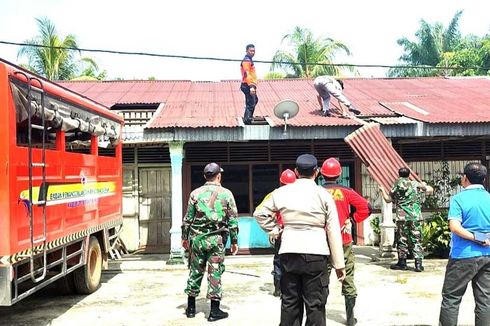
[344,123,421,190]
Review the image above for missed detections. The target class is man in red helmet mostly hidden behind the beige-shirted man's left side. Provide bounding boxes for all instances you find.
[257,169,296,297]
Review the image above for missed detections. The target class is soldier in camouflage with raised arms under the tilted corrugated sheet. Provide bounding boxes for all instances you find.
[381,168,432,272]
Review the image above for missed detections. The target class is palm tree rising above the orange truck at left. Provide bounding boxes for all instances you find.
[17,17,78,80]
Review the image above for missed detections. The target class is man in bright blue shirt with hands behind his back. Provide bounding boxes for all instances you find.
[439,163,490,326]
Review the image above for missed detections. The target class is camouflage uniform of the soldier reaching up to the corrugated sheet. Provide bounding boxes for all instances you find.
[391,177,424,259]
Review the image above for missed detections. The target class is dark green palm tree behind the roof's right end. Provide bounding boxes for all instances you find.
[388,10,463,77]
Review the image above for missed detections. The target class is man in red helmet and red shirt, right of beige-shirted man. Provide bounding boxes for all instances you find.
[321,158,372,325]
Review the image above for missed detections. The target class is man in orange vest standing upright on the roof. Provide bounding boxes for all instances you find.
[240,44,259,125]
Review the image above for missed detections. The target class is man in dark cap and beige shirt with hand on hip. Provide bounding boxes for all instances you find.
[254,154,345,326]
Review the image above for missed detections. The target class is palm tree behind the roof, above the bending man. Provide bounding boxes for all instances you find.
[271,26,354,78]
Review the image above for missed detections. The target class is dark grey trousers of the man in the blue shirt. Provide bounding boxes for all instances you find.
[439,256,490,326]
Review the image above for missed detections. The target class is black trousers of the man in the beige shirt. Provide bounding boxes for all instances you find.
[280,253,328,326]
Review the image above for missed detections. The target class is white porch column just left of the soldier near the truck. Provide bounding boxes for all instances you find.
[167,142,185,265]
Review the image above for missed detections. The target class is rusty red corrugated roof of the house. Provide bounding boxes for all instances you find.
[62,77,490,128]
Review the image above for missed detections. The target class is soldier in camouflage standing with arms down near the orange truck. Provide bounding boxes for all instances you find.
[182,163,238,321]
